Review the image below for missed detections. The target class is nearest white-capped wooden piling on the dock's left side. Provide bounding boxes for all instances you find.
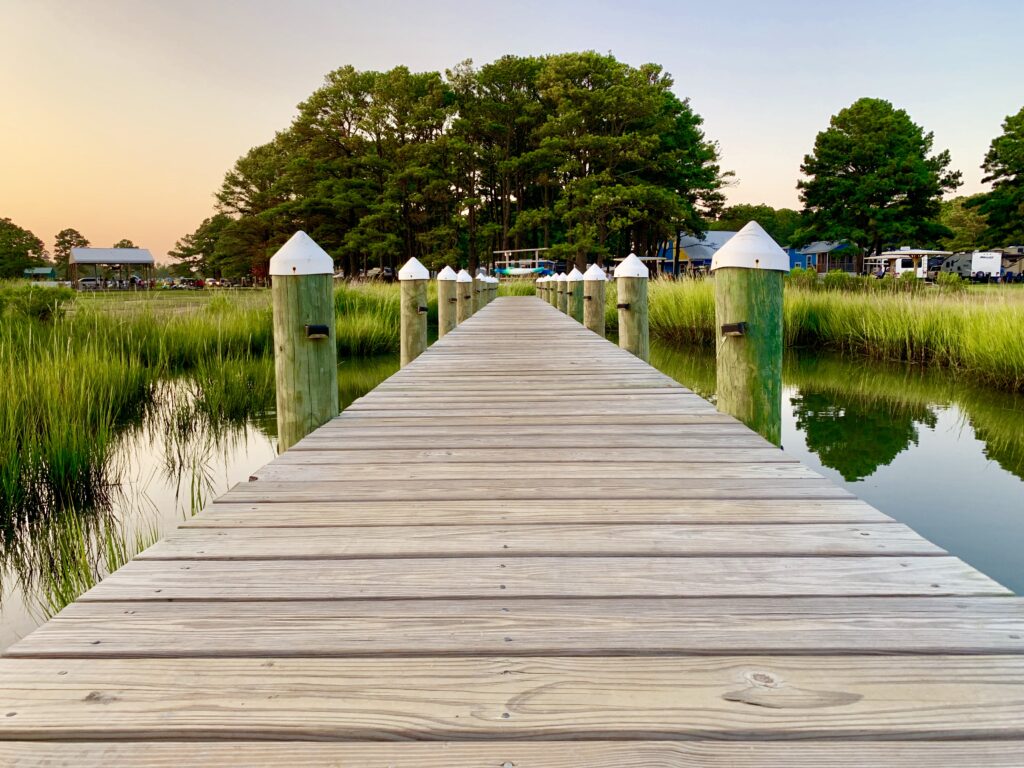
[270,231,338,452]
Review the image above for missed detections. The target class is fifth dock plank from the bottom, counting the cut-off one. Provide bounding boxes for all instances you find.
[138,523,945,560]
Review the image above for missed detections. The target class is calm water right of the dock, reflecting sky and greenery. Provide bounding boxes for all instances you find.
[651,347,1024,594]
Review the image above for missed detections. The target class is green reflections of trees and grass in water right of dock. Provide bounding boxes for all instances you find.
[651,344,1024,480]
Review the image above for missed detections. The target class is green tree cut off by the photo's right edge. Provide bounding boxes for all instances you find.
[969,108,1024,248]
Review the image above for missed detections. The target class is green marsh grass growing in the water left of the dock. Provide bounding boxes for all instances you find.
[0,285,411,612]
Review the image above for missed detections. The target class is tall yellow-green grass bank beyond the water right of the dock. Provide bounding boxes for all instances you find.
[607,281,1024,391]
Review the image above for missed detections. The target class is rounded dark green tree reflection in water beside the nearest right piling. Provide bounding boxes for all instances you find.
[790,388,936,482]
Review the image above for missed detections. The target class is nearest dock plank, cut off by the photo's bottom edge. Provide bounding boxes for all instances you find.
[8,740,1024,768]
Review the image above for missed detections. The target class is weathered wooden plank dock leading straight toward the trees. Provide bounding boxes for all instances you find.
[0,297,1024,768]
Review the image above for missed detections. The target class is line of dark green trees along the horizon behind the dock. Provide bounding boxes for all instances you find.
[0,58,1024,278]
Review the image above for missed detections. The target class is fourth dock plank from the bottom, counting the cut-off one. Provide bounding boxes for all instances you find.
[80,556,1012,600]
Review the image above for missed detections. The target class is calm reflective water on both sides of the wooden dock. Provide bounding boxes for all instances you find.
[0,346,1024,648]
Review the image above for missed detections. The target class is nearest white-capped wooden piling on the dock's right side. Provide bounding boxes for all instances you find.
[711,221,790,445]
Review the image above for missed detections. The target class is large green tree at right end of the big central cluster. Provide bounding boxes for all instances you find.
[539,51,721,267]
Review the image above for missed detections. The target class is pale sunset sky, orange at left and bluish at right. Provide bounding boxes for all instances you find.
[0,0,1024,259]
